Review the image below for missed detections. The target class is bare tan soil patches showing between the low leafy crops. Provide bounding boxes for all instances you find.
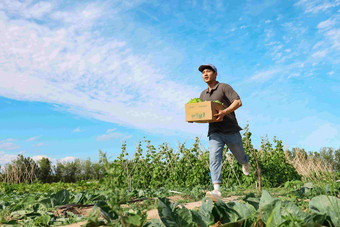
[61,195,240,227]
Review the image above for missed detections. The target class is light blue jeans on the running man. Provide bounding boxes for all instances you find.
[209,132,249,184]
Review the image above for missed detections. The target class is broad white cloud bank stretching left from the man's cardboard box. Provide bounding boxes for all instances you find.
[0,1,200,133]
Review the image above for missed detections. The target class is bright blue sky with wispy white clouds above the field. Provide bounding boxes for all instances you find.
[0,0,340,165]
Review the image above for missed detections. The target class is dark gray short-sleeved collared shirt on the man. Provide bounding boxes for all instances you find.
[200,81,242,136]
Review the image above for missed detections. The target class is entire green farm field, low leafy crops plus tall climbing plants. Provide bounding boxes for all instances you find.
[0,134,340,227]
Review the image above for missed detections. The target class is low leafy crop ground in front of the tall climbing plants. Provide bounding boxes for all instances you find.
[0,181,340,226]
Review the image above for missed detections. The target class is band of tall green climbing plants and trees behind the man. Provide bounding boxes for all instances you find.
[0,126,340,185]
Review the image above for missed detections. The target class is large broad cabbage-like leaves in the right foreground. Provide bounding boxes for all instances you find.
[158,190,340,227]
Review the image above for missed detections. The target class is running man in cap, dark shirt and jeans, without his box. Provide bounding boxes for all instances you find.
[198,64,250,200]
